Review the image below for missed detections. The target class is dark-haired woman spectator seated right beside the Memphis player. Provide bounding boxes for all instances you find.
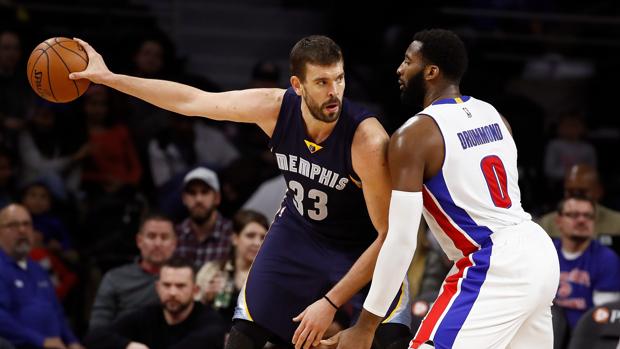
[197,210,269,329]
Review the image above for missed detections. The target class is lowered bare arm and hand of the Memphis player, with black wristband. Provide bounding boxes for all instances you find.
[293,118,390,349]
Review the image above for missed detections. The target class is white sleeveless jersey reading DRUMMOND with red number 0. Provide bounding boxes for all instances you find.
[419,96,531,260]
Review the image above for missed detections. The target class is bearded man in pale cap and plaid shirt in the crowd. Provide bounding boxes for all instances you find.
[174,167,232,269]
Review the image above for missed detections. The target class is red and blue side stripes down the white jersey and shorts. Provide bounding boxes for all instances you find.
[411,171,493,348]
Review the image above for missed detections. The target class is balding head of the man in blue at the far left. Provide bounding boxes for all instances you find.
[0,204,32,261]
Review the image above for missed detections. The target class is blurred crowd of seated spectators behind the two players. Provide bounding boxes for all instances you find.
[0,1,620,349]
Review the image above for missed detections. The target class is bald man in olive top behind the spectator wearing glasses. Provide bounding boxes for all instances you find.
[539,164,620,237]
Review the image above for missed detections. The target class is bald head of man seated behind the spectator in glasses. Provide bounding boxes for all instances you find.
[564,164,603,202]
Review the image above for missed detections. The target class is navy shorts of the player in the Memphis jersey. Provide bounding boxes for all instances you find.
[234,210,411,342]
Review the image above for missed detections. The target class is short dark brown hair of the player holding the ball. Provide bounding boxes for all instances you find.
[290,35,343,81]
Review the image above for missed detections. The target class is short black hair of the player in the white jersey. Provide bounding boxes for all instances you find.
[413,29,467,83]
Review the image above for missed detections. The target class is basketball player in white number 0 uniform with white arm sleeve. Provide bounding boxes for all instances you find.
[322,29,559,349]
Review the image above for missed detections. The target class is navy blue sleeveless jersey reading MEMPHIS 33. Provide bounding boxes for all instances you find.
[270,88,377,245]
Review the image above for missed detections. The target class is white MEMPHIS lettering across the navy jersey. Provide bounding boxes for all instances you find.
[275,153,349,190]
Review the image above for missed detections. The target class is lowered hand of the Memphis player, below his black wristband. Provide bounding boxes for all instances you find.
[293,298,336,349]
